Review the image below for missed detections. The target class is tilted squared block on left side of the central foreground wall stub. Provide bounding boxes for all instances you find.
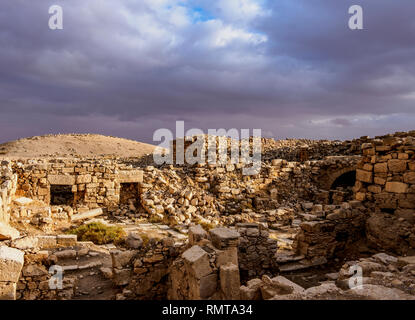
[182,246,212,279]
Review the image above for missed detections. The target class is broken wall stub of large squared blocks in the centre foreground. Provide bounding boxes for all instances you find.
[168,226,240,300]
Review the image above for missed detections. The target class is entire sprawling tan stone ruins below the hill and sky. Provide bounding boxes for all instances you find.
[0,131,415,300]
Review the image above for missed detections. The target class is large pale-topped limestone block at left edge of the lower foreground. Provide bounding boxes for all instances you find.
[0,246,24,282]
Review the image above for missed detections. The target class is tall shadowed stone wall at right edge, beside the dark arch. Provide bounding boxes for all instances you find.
[355,132,415,254]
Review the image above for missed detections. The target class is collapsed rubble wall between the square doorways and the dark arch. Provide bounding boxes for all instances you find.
[141,156,359,225]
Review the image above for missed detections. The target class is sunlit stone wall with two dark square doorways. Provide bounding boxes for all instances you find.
[9,159,142,209]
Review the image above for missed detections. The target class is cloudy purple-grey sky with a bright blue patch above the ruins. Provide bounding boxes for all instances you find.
[0,0,415,142]
